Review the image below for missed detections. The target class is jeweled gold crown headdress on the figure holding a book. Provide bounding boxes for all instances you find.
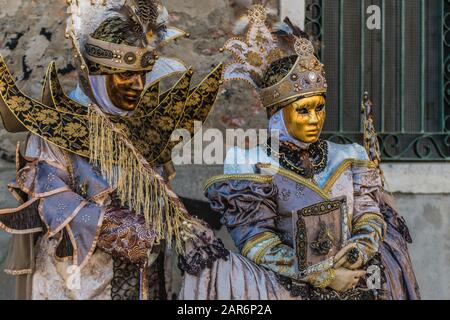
[224,5,328,116]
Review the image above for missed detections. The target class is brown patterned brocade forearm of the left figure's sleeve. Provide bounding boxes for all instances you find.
[97,207,156,268]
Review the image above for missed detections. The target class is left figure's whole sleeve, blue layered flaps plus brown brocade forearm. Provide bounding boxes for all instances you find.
[5,139,158,266]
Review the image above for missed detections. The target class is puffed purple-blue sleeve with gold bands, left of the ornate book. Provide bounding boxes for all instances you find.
[206,179,295,278]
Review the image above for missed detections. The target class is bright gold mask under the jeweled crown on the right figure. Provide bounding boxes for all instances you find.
[283,95,326,143]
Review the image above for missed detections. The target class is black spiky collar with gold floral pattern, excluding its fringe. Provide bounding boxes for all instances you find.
[0,57,223,164]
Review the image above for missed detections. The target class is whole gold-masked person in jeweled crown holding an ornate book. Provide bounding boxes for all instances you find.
[183,5,420,299]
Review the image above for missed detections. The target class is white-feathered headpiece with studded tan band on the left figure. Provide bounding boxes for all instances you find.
[66,0,186,75]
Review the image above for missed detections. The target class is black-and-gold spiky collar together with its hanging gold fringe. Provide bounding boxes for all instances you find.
[0,57,221,254]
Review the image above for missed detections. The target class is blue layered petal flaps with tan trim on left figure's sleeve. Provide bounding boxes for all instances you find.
[11,155,104,266]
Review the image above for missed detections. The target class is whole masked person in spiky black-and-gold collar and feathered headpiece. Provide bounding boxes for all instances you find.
[0,0,228,299]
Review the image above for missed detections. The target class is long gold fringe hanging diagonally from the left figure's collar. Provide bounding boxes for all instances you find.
[89,106,197,253]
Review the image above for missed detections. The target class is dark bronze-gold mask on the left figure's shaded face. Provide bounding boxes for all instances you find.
[105,71,145,111]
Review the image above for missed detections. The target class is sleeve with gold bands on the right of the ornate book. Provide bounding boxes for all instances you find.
[350,166,386,263]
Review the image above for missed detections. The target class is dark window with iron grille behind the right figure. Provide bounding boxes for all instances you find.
[305,0,450,161]
